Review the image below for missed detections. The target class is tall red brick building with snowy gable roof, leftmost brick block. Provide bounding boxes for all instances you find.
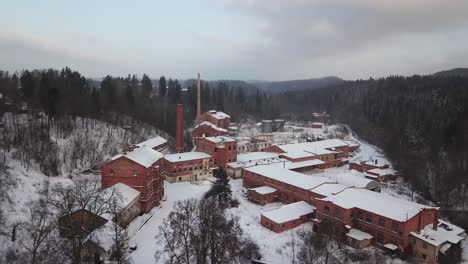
[101,146,164,212]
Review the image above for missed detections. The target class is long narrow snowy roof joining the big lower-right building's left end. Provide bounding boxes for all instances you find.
[244,165,331,190]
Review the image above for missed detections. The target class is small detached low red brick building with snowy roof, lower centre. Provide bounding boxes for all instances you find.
[260,201,315,233]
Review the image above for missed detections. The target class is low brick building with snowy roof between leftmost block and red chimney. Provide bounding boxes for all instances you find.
[161,152,213,182]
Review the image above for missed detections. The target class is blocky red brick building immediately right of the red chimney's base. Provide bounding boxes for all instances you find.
[195,136,237,171]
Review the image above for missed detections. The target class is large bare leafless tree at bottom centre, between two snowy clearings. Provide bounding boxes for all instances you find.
[156,198,250,264]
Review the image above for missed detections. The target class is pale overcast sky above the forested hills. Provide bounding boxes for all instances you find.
[0,0,468,80]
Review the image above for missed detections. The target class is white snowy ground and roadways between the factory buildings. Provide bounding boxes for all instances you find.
[129,124,428,264]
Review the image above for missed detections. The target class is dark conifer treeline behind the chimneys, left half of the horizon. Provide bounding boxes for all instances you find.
[0,68,278,138]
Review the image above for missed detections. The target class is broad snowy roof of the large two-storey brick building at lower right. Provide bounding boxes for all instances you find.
[321,188,434,222]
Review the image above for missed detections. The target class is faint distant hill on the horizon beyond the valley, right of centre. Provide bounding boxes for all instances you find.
[251,76,344,93]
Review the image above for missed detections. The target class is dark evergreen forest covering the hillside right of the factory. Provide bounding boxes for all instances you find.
[274,76,468,227]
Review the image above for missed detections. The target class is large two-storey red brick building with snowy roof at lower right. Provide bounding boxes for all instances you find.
[314,188,438,252]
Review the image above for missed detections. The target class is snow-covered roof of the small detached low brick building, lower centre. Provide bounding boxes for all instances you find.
[262,201,316,224]
